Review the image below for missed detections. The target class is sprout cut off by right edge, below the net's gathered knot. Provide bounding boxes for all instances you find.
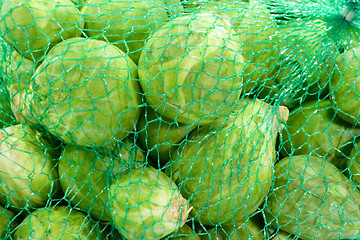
[330,46,360,125]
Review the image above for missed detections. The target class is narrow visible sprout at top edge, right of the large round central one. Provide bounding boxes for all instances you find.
[235,1,282,98]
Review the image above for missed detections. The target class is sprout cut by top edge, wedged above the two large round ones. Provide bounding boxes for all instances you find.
[81,0,182,63]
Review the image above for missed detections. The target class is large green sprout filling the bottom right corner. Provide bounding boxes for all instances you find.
[265,155,360,239]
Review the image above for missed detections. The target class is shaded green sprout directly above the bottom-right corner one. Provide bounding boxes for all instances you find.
[280,99,360,170]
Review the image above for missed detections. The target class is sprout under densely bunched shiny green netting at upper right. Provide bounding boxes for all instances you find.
[261,19,338,108]
